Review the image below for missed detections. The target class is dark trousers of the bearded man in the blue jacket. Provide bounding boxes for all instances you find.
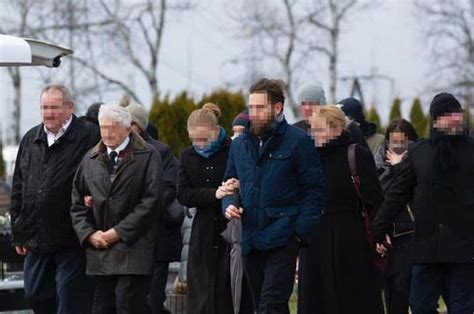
[244,238,299,314]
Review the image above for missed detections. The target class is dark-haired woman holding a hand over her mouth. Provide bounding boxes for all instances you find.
[375,119,418,314]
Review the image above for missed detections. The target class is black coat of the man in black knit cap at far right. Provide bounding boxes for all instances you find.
[372,136,474,263]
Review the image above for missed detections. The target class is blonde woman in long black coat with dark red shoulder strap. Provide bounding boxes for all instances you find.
[298,106,383,314]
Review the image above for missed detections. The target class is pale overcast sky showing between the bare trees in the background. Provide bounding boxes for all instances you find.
[0,0,432,139]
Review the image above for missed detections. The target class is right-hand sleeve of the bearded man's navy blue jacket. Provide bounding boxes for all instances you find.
[295,136,325,238]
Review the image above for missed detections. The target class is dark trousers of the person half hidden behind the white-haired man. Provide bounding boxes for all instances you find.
[148,261,170,314]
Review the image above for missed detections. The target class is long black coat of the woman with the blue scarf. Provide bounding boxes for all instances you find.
[178,140,233,314]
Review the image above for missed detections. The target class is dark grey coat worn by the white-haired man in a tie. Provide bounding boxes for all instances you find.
[71,133,163,275]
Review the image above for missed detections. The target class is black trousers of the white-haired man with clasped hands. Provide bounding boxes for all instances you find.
[92,275,150,314]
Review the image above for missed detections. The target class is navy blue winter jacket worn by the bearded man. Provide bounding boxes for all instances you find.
[223,120,324,255]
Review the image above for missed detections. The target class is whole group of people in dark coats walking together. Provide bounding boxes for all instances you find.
[7,79,474,314]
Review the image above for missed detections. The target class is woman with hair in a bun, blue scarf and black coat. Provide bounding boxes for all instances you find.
[178,103,250,314]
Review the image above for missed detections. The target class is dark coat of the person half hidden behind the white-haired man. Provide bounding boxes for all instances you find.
[143,133,184,262]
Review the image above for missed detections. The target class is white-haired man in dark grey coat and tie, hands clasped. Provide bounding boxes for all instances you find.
[71,105,162,313]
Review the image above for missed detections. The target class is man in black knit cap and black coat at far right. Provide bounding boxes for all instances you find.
[373,93,474,314]
